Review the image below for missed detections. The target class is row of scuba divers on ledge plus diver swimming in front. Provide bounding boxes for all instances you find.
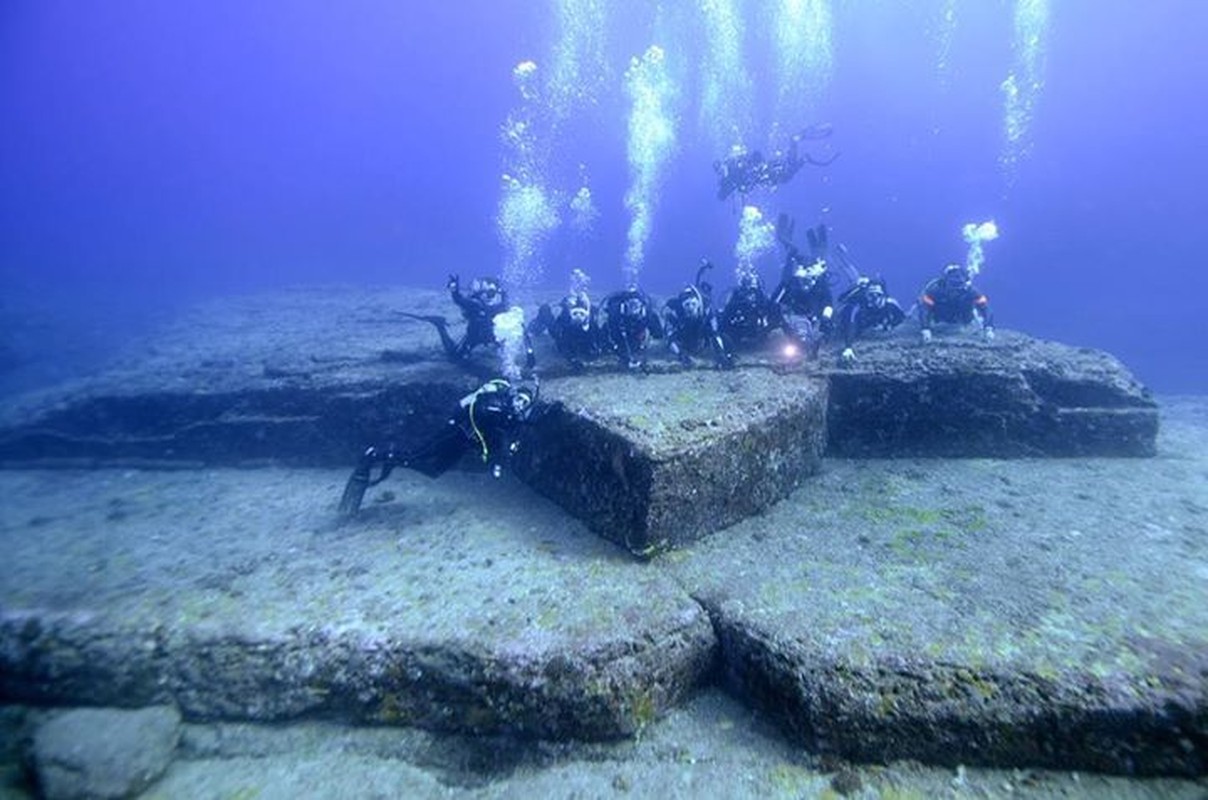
[339,214,994,516]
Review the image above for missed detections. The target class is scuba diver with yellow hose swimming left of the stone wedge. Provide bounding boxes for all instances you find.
[339,378,538,516]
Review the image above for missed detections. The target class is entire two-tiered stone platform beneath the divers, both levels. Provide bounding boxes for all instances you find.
[0,291,1208,776]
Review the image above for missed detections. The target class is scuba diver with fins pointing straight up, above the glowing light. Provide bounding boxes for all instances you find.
[772,214,835,354]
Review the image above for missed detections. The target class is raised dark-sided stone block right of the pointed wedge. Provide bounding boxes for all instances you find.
[827,331,1157,458]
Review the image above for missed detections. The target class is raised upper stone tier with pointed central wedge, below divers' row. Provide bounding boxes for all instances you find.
[0,290,1157,553]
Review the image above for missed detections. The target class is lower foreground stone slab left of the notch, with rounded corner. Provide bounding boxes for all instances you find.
[0,470,716,740]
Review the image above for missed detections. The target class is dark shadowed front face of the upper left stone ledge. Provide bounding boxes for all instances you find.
[0,384,463,468]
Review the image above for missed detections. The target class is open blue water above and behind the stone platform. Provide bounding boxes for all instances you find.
[0,0,1208,392]
